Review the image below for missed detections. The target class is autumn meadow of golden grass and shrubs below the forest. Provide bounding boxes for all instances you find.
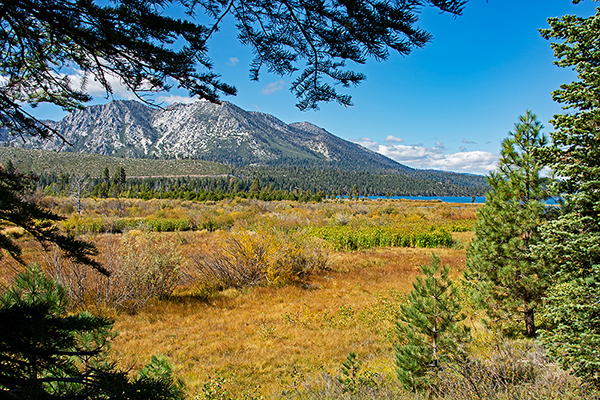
[3,197,592,399]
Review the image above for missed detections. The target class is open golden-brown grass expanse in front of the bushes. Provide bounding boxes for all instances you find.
[113,244,464,396]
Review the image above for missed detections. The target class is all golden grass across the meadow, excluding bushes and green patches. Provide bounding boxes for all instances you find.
[0,198,478,397]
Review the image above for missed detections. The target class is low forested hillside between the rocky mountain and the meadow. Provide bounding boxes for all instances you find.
[0,147,486,198]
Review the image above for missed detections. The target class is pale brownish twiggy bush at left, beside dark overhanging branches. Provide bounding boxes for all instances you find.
[44,231,185,313]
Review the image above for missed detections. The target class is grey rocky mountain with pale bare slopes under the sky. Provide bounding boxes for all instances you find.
[0,100,409,170]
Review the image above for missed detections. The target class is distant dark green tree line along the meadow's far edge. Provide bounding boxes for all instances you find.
[25,166,485,201]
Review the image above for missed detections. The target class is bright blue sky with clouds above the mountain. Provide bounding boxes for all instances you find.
[29,0,597,174]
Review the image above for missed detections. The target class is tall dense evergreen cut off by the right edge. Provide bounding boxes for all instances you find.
[536,9,600,386]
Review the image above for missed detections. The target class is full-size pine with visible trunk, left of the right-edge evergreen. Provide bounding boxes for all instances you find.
[465,111,550,337]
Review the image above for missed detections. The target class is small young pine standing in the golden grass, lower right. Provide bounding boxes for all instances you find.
[395,255,469,391]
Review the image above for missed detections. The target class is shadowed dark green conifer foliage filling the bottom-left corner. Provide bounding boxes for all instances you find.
[0,269,184,400]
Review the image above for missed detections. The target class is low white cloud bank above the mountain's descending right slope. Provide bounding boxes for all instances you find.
[356,138,499,174]
